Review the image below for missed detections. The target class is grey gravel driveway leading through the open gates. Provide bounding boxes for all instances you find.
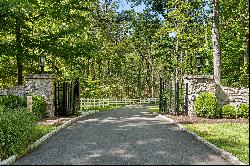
[14,106,230,165]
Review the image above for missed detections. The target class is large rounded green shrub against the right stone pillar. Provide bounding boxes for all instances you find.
[194,92,220,118]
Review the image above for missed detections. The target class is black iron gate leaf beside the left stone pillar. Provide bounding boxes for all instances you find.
[54,81,80,116]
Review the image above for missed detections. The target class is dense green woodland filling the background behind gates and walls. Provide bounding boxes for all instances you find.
[0,0,249,98]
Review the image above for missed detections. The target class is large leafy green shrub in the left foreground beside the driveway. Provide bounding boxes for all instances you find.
[0,108,36,159]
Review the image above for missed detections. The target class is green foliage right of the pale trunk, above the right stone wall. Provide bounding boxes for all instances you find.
[219,0,249,87]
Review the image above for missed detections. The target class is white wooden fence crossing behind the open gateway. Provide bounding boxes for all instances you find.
[80,98,159,110]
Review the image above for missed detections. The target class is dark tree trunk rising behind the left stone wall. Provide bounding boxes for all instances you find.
[16,17,23,85]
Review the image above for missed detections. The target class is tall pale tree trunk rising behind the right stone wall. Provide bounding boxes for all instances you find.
[212,0,221,84]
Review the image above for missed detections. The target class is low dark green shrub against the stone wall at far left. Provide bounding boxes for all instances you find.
[0,95,27,109]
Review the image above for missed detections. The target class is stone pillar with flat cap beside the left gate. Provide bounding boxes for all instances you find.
[25,74,57,117]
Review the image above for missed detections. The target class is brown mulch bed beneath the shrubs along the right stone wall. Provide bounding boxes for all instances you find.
[165,115,249,124]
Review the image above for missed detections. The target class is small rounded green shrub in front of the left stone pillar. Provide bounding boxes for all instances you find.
[32,96,47,118]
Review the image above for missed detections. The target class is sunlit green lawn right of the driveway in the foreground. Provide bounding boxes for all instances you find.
[185,123,249,164]
